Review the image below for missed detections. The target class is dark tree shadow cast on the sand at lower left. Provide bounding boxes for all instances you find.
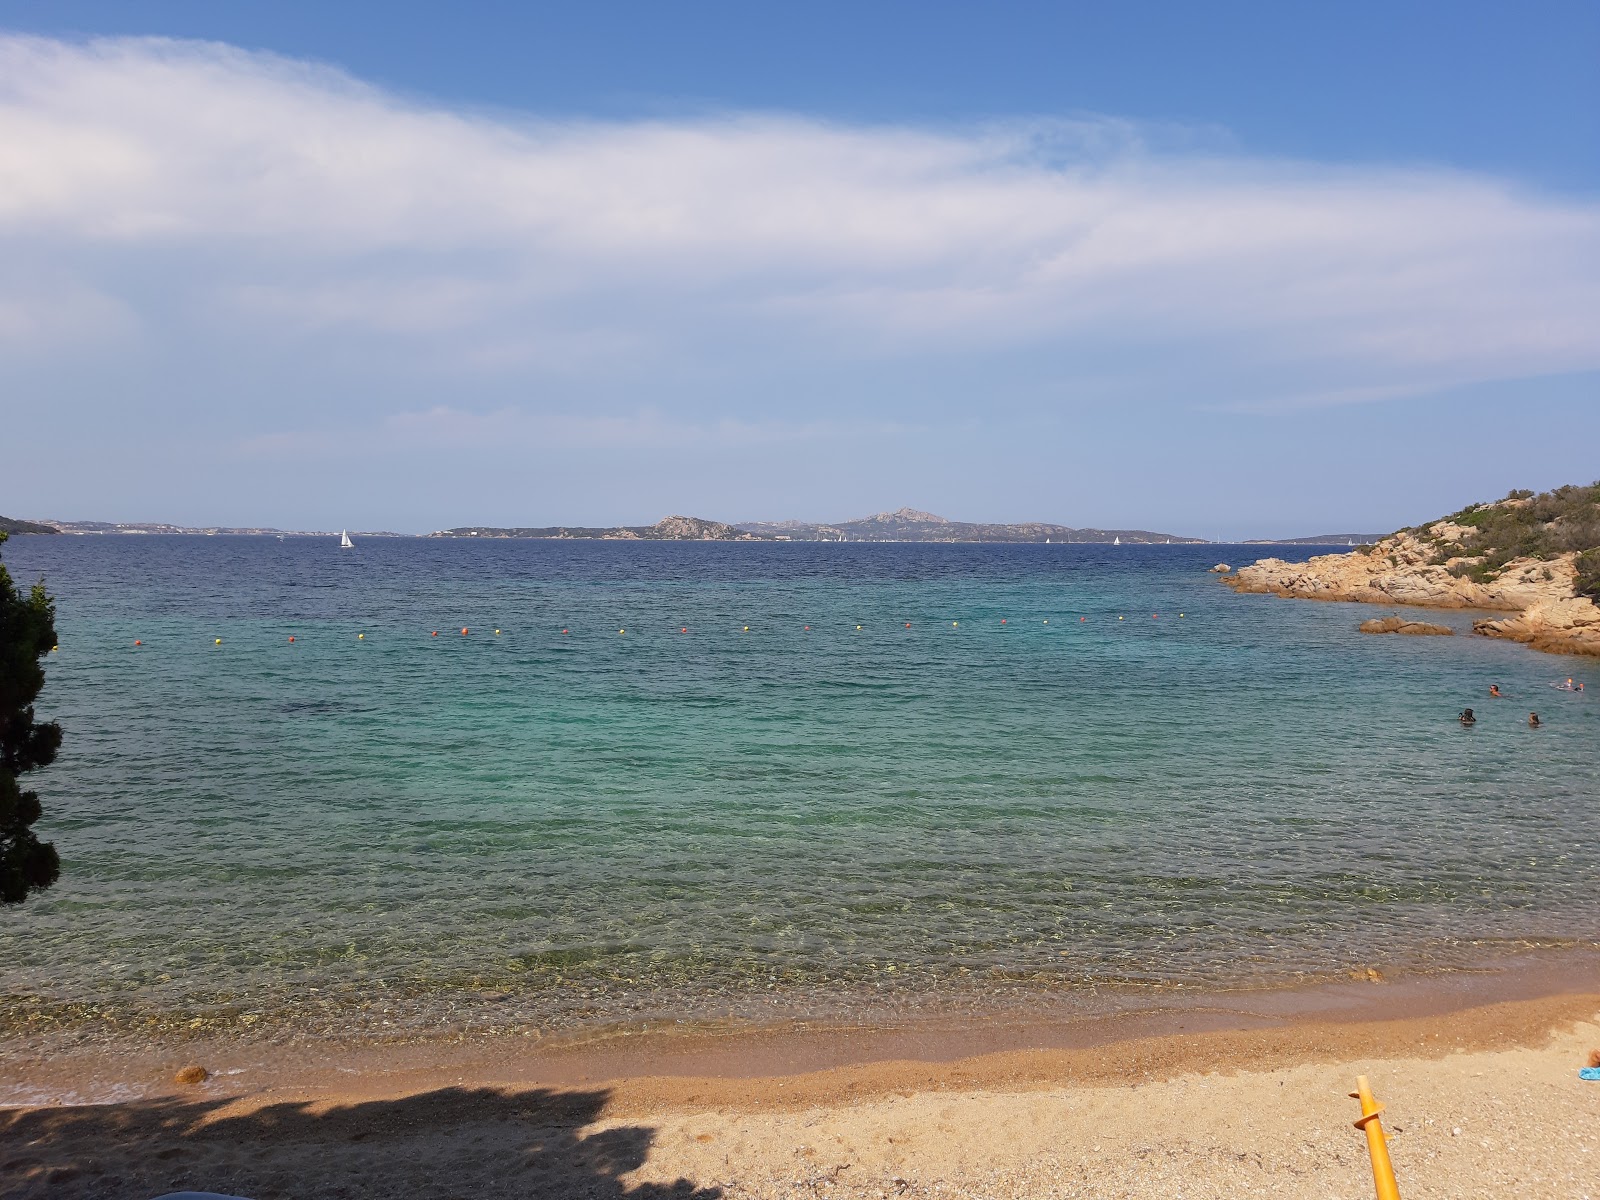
[0,1088,722,1200]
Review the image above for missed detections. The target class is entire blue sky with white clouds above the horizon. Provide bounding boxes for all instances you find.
[0,0,1600,538]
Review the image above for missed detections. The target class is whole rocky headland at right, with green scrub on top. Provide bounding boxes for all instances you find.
[1222,485,1600,656]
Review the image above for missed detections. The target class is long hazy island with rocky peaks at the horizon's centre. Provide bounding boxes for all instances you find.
[429,509,1206,546]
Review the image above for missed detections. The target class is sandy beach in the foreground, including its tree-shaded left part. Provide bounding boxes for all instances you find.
[0,995,1600,1200]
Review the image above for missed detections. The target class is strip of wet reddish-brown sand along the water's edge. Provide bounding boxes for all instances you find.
[0,947,1600,1109]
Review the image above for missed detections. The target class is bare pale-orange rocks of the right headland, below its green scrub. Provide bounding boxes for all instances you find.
[1222,508,1600,656]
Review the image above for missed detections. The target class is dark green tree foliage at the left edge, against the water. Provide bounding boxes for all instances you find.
[0,531,61,904]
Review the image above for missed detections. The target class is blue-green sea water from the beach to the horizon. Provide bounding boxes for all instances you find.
[0,538,1600,1032]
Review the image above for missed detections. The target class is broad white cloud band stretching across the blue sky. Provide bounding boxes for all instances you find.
[0,38,1600,419]
